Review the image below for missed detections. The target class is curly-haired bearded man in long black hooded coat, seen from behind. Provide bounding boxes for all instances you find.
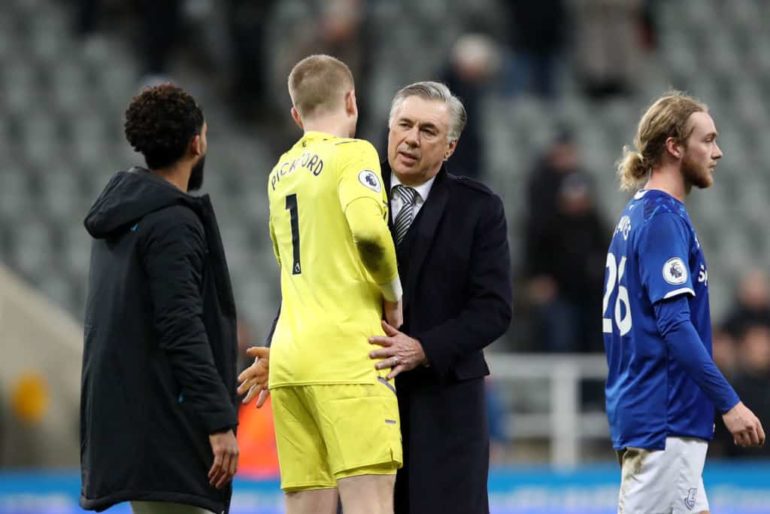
[80,84,238,514]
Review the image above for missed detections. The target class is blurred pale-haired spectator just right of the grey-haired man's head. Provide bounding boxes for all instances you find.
[441,34,499,178]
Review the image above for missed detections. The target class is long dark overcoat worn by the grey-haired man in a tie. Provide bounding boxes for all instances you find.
[383,164,511,514]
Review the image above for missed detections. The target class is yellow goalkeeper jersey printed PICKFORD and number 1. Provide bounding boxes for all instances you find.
[268,132,398,388]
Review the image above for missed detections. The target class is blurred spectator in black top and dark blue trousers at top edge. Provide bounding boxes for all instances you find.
[501,0,568,98]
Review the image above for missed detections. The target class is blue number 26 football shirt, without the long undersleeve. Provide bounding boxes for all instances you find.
[602,190,714,450]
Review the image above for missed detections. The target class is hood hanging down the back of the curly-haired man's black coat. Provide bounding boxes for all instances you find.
[84,167,194,239]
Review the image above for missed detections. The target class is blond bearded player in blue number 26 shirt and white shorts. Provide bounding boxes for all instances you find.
[602,92,765,514]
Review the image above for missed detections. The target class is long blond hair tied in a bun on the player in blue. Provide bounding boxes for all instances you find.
[617,91,708,191]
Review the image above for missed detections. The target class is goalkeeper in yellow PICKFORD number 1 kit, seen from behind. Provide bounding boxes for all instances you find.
[239,55,402,514]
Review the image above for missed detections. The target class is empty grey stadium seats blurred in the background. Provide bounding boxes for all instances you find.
[0,0,770,346]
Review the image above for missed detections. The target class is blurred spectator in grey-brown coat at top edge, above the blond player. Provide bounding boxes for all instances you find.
[574,0,642,99]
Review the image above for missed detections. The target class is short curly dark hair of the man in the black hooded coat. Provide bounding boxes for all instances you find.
[124,84,203,169]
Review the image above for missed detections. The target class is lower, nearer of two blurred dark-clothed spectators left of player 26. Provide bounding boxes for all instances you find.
[526,172,608,352]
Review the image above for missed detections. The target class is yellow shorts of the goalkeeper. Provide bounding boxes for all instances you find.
[270,379,403,492]
